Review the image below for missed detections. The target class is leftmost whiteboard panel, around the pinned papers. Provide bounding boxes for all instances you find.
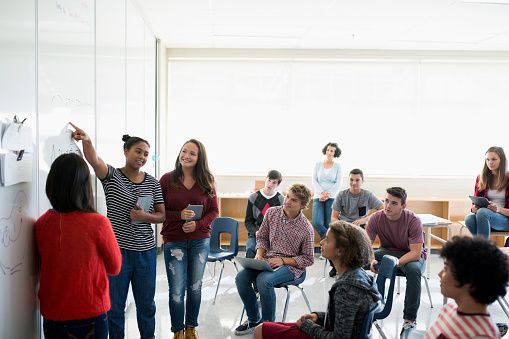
[0,0,39,338]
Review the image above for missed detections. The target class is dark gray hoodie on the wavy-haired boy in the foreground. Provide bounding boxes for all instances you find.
[300,268,381,339]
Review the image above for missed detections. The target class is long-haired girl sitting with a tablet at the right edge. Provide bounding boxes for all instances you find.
[465,146,509,238]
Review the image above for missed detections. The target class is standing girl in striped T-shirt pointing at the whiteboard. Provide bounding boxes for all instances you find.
[71,123,164,339]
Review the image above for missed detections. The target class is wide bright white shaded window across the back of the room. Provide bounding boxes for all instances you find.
[166,49,509,191]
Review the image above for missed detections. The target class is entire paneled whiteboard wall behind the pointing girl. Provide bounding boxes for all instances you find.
[0,0,155,339]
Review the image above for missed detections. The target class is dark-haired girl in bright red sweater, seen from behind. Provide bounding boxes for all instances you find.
[35,154,122,339]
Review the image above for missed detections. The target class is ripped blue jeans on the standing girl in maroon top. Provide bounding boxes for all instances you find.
[164,238,210,332]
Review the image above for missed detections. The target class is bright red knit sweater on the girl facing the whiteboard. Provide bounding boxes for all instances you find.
[35,210,122,321]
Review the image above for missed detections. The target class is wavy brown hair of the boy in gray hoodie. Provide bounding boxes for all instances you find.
[329,220,373,268]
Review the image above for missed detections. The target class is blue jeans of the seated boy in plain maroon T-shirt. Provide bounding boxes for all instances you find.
[375,247,425,321]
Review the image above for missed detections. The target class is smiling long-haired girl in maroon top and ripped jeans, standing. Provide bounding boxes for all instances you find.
[160,139,219,339]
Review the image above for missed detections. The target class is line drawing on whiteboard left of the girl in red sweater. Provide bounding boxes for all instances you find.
[0,191,30,276]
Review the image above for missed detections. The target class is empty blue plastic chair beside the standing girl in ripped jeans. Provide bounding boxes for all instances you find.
[207,217,239,304]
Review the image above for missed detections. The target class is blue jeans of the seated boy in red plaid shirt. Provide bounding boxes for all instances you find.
[235,265,294,322]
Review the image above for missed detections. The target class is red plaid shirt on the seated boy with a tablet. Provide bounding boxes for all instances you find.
[256,206,315,279]
